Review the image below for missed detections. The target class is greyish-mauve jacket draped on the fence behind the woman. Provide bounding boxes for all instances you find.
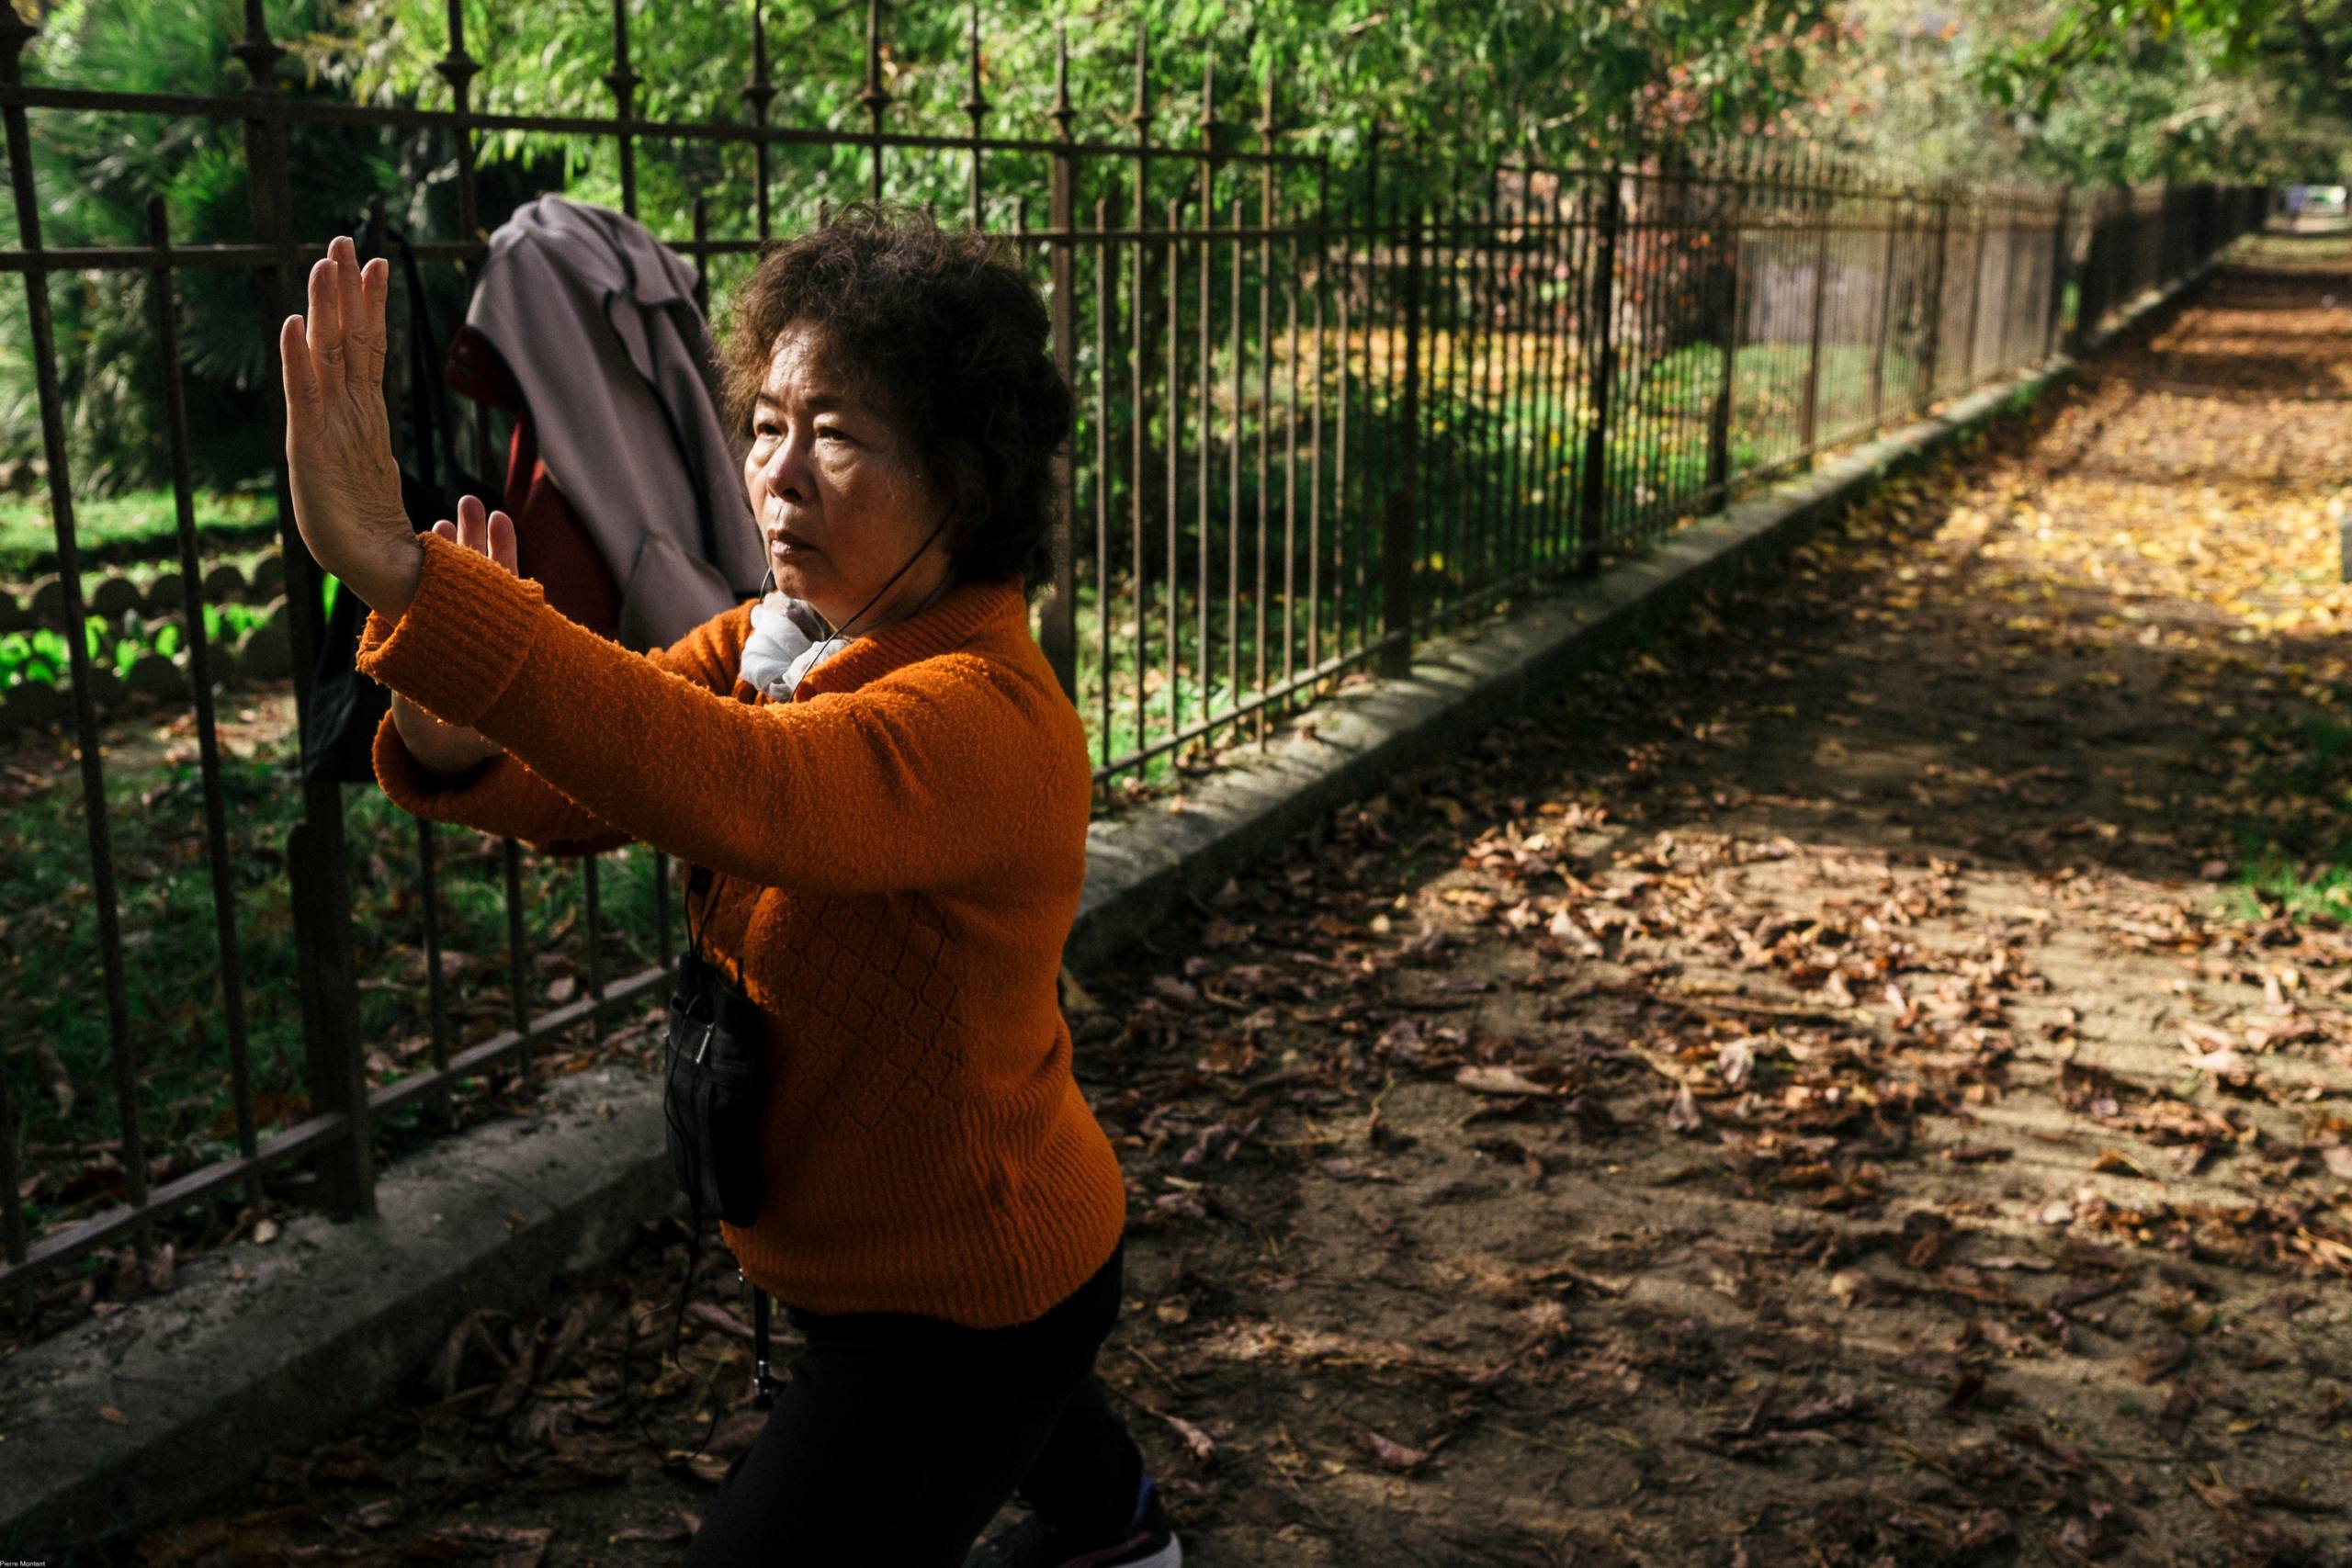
[466,195,767,653]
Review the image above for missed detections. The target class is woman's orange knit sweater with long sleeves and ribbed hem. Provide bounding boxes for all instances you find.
[357,534,1126,1328]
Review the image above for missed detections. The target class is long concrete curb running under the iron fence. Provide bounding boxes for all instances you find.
[0,264,2213,1563]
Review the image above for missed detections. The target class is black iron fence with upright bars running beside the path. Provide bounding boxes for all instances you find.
[0,0,2263,1293]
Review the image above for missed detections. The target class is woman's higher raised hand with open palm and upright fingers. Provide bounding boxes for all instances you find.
[277,237,424,621]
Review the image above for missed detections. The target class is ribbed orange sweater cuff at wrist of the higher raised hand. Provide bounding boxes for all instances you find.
[353,534,546,724]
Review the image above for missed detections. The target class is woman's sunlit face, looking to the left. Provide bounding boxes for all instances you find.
[743,324,948,635]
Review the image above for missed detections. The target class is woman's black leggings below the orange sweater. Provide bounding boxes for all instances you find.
[687,1246,1143,1568]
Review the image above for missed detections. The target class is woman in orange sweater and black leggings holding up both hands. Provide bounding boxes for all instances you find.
[280,207,1181,1568]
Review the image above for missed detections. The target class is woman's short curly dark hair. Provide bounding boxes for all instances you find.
[719,202,1070,597]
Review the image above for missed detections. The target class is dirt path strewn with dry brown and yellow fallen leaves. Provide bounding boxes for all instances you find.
[106,240,2352,1568]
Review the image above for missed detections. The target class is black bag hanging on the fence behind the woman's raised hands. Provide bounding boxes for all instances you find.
[301,219,492,783]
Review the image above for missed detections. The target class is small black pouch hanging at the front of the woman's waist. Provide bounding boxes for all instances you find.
[661,952,764,1227]
